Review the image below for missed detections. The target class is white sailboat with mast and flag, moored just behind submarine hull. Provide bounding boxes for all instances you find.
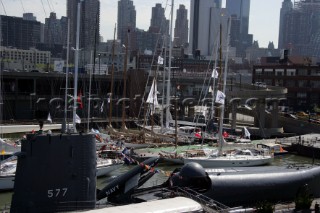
[184,19,273,168]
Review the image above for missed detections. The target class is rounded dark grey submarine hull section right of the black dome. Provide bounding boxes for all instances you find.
[205,167,320,206]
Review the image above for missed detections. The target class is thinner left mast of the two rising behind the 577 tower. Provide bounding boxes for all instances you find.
[62,19,70,132]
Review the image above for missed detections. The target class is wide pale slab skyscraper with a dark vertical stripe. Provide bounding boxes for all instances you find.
[189,0,221,56]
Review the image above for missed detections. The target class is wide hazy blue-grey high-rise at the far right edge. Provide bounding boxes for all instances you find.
[282,0,320,57]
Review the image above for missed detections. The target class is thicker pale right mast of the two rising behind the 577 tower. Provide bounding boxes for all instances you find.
[72,1,82,132]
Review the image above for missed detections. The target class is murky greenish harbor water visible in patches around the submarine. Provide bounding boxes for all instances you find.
[0,154,320,211]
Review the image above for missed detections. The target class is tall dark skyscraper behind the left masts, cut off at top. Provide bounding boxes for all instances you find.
[66,0,100,65]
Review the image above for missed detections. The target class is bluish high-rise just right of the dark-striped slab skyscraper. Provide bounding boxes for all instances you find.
[226,0,253,57]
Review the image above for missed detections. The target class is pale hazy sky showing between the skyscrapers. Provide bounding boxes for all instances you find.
[0,0,282,47]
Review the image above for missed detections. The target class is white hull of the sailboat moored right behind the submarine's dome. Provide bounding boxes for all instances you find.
[184,156,273,168]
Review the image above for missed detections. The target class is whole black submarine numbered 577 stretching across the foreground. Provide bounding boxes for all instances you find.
[11,134,320,212]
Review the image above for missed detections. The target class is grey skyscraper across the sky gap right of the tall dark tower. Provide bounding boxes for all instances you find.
[117,0,136,44]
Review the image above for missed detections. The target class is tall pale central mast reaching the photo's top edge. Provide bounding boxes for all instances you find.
[166,0,174,128]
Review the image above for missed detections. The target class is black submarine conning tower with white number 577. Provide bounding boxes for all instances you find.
[10,134,96,213]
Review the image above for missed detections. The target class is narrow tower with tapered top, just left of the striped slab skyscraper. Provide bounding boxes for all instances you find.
[173,4,189,47]
